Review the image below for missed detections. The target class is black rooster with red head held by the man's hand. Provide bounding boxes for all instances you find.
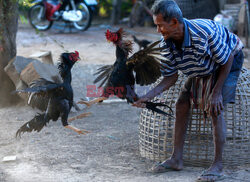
[79,29,171,115]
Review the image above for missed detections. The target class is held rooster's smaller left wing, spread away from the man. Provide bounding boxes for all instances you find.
[94,65,114,87]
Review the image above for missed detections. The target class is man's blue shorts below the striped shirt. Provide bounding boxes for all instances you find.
[179,50,244,104]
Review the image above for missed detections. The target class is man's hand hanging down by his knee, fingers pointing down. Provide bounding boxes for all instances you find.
[207,92,223,117]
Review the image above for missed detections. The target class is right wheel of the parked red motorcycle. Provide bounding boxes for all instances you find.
[73,3,92,31]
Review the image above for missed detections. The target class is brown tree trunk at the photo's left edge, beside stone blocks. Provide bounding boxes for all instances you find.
[0,0,18,106]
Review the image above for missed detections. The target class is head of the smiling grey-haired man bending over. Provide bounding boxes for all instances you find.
[151,0,183,40]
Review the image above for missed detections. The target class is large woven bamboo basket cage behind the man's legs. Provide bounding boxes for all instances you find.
[139,69,250,166]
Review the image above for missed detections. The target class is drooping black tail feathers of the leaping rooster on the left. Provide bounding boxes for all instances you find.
[16,113,49,137]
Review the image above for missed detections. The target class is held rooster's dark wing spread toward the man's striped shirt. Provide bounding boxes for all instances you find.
[126,41,166,86]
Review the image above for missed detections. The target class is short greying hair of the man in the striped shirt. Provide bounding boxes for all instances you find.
[151,0,183,23]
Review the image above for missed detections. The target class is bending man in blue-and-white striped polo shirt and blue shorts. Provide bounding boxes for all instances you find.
[134,0,243,181]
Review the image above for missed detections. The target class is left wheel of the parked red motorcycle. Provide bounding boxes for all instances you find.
[28,4,53,31]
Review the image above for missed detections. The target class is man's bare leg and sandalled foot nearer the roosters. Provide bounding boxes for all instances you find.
[153,92,190,173]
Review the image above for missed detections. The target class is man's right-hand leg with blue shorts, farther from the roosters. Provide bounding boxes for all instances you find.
[198,51,244,181]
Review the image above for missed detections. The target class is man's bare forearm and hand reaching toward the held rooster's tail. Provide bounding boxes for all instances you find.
[133,73,178,108]
